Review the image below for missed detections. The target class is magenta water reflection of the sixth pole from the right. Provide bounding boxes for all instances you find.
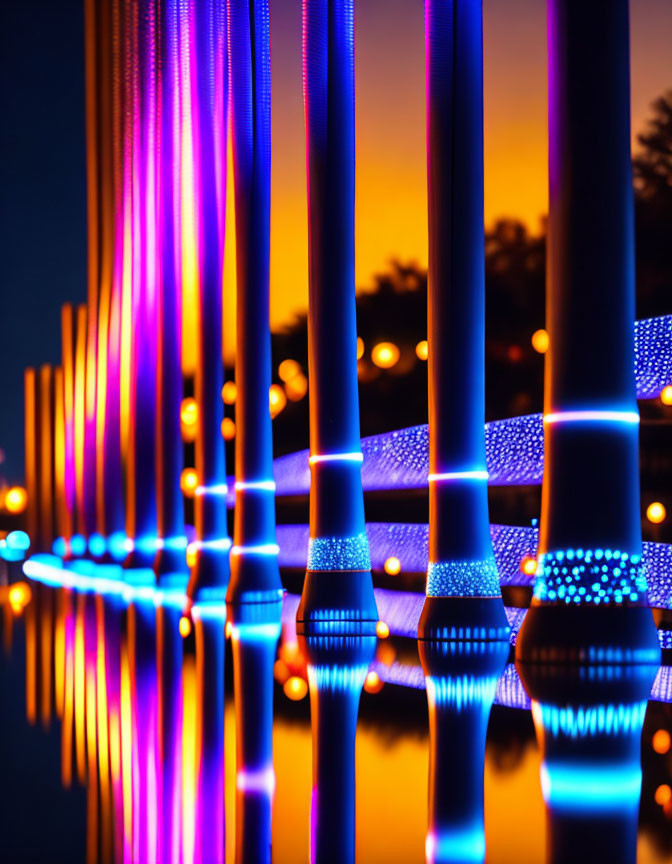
[156,603,183,861]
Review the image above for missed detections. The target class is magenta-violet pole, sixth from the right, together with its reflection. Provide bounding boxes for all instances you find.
[154,0,189,861]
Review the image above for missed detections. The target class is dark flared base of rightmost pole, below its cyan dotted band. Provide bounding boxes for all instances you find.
[516,603,661,664]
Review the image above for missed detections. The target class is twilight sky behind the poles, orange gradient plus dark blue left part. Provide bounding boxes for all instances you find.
[0,0,672,479]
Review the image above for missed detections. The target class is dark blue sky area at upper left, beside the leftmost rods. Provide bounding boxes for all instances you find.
[0,0,86,481]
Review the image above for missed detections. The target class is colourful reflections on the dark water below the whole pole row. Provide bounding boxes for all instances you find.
[0,572,672,864]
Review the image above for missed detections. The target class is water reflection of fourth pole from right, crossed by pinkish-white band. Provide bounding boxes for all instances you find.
[231,602,281,864]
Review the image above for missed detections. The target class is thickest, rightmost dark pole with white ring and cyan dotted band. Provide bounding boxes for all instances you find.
[517,0,656,660]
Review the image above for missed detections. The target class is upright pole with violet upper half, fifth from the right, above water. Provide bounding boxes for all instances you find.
[183,0,230,603]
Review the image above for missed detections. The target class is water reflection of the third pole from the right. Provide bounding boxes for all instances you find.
[299,636,376,864]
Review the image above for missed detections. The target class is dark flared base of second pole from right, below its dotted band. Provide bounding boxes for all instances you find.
[418,597,511,644]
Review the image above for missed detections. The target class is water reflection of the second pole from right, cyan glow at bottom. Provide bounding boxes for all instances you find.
[418,640,509,864]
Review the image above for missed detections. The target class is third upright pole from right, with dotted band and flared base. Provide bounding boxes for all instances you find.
[297,0,378,626]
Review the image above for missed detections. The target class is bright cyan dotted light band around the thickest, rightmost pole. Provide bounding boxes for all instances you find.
[534,549,646,605]
